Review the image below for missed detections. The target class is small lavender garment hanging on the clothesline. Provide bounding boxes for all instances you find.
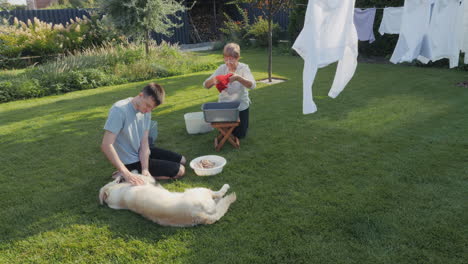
[354,8,376,43]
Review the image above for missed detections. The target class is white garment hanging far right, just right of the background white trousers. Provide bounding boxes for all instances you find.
[418,0,461,68]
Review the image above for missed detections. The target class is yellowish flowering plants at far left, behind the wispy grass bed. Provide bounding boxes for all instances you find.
[0,14,126,68]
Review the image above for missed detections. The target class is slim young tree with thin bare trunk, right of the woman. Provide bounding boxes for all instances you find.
[238,0,293,82]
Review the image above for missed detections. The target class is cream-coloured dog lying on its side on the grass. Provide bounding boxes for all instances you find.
[99,175,236,227]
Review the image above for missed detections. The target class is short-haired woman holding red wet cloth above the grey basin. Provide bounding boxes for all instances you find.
[203,43,255,138]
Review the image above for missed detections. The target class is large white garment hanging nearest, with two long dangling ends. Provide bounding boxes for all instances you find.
[292,0,358,114]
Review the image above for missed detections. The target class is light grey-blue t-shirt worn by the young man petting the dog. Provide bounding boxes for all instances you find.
[104,97,151,164]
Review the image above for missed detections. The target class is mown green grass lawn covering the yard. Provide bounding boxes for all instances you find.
[0,51,468,263]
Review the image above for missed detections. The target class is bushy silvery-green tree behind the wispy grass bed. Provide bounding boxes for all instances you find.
[102,0,186,55]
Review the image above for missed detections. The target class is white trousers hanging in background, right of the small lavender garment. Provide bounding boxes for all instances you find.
[390,0,434,63]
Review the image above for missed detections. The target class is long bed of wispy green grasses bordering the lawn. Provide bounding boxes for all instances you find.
[0,43,217,103]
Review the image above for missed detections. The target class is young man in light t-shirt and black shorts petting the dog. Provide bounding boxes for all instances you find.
[101,83,186,185]
